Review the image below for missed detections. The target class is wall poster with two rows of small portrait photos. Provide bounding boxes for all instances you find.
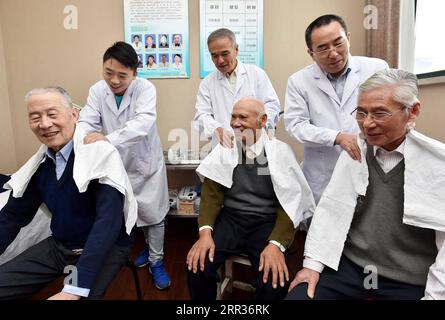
[124,0,190,78]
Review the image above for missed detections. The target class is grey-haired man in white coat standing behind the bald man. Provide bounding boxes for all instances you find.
[193,28,280,147]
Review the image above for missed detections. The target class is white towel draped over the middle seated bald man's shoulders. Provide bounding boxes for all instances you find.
[196,131,315,228]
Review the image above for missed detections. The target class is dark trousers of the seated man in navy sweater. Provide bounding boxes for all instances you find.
[0,237,131,300]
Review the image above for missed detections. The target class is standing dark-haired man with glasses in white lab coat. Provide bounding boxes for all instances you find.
[284,14,388,202]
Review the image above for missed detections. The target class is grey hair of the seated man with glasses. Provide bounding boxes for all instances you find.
[358,69,419,108]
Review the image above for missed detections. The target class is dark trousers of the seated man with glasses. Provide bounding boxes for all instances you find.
[286,255,425,300]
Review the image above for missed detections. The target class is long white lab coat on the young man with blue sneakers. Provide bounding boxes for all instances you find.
[78,78,169,226]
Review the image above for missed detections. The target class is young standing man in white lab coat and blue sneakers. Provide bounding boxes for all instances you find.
[78,42,171,289]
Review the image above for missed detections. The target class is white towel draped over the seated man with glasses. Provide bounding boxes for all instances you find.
[303,130,445,299]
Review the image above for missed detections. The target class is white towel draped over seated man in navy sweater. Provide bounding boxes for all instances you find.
[0,130,137,264]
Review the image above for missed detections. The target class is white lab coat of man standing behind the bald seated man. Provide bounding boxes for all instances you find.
[193,61,280,145]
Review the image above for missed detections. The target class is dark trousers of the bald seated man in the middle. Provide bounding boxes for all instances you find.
[188,209,289,300]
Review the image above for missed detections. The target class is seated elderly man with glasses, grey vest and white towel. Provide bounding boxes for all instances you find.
[287,69,445,299]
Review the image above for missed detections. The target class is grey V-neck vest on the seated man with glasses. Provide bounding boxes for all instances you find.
[343,146,437,286]
